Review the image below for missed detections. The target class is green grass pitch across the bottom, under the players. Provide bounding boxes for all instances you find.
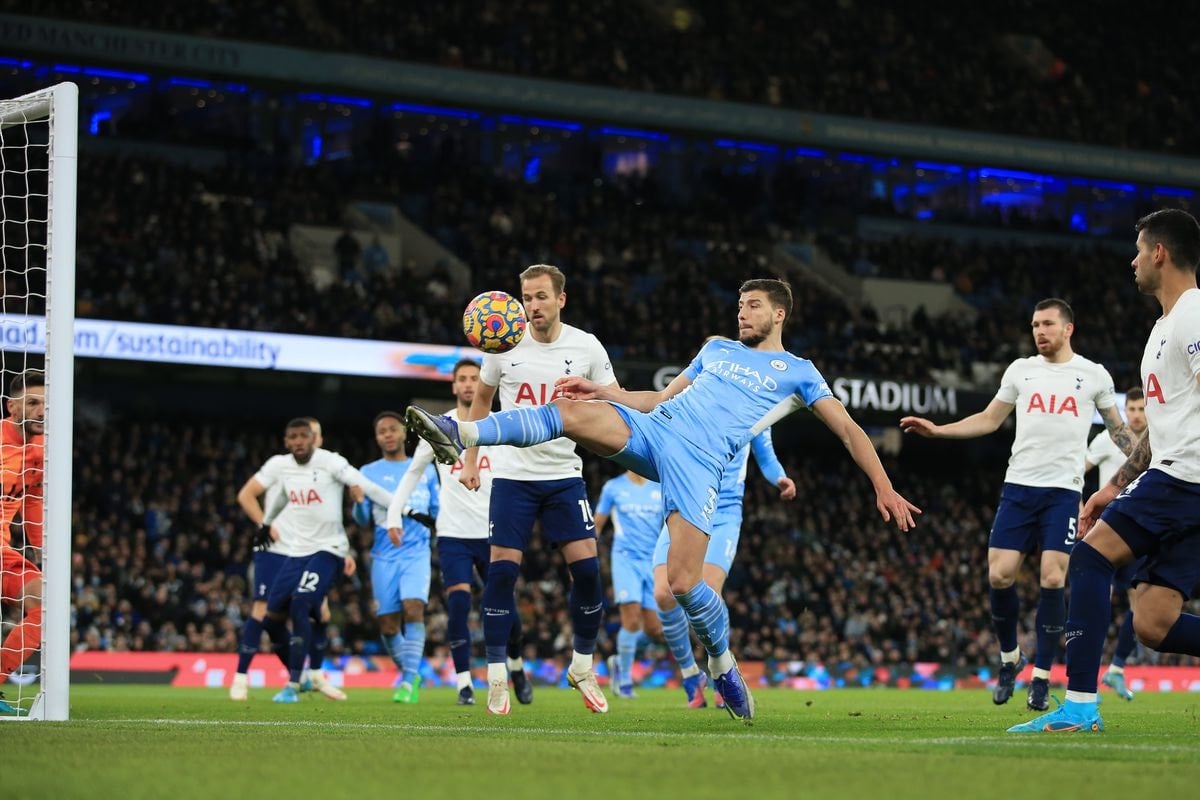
[0,686,1200,800]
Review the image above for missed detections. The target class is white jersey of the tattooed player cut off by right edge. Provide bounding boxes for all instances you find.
[1141,289,1200,483]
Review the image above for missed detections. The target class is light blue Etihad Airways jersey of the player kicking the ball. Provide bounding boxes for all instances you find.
[654,339,833,465]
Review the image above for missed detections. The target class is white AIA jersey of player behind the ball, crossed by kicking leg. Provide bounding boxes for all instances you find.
[479,325,617,481]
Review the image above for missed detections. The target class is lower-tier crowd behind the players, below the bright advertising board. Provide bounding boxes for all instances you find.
[60,419,1195,668]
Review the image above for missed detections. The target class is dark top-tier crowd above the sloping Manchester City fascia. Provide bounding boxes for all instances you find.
[23,0,1200,152]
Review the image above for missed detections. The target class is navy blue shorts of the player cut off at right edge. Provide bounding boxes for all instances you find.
[1100,469,1200,599]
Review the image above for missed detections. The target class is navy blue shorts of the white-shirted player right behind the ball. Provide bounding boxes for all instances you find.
[488,477,596,553]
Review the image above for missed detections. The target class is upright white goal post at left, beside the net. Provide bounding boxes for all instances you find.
[35,83,79,720]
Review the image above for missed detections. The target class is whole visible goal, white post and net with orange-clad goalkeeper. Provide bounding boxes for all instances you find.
[0,84,79,722]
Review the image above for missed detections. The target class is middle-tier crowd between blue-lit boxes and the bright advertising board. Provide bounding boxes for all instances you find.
[68,143,1154,390]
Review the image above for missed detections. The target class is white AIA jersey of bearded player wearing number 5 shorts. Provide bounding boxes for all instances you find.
[996,355,1117,492]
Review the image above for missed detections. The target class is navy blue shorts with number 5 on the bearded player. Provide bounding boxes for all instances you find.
[988,483,1079,553]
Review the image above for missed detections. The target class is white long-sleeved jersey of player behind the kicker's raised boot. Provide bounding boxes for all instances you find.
[386,407,497,539]
